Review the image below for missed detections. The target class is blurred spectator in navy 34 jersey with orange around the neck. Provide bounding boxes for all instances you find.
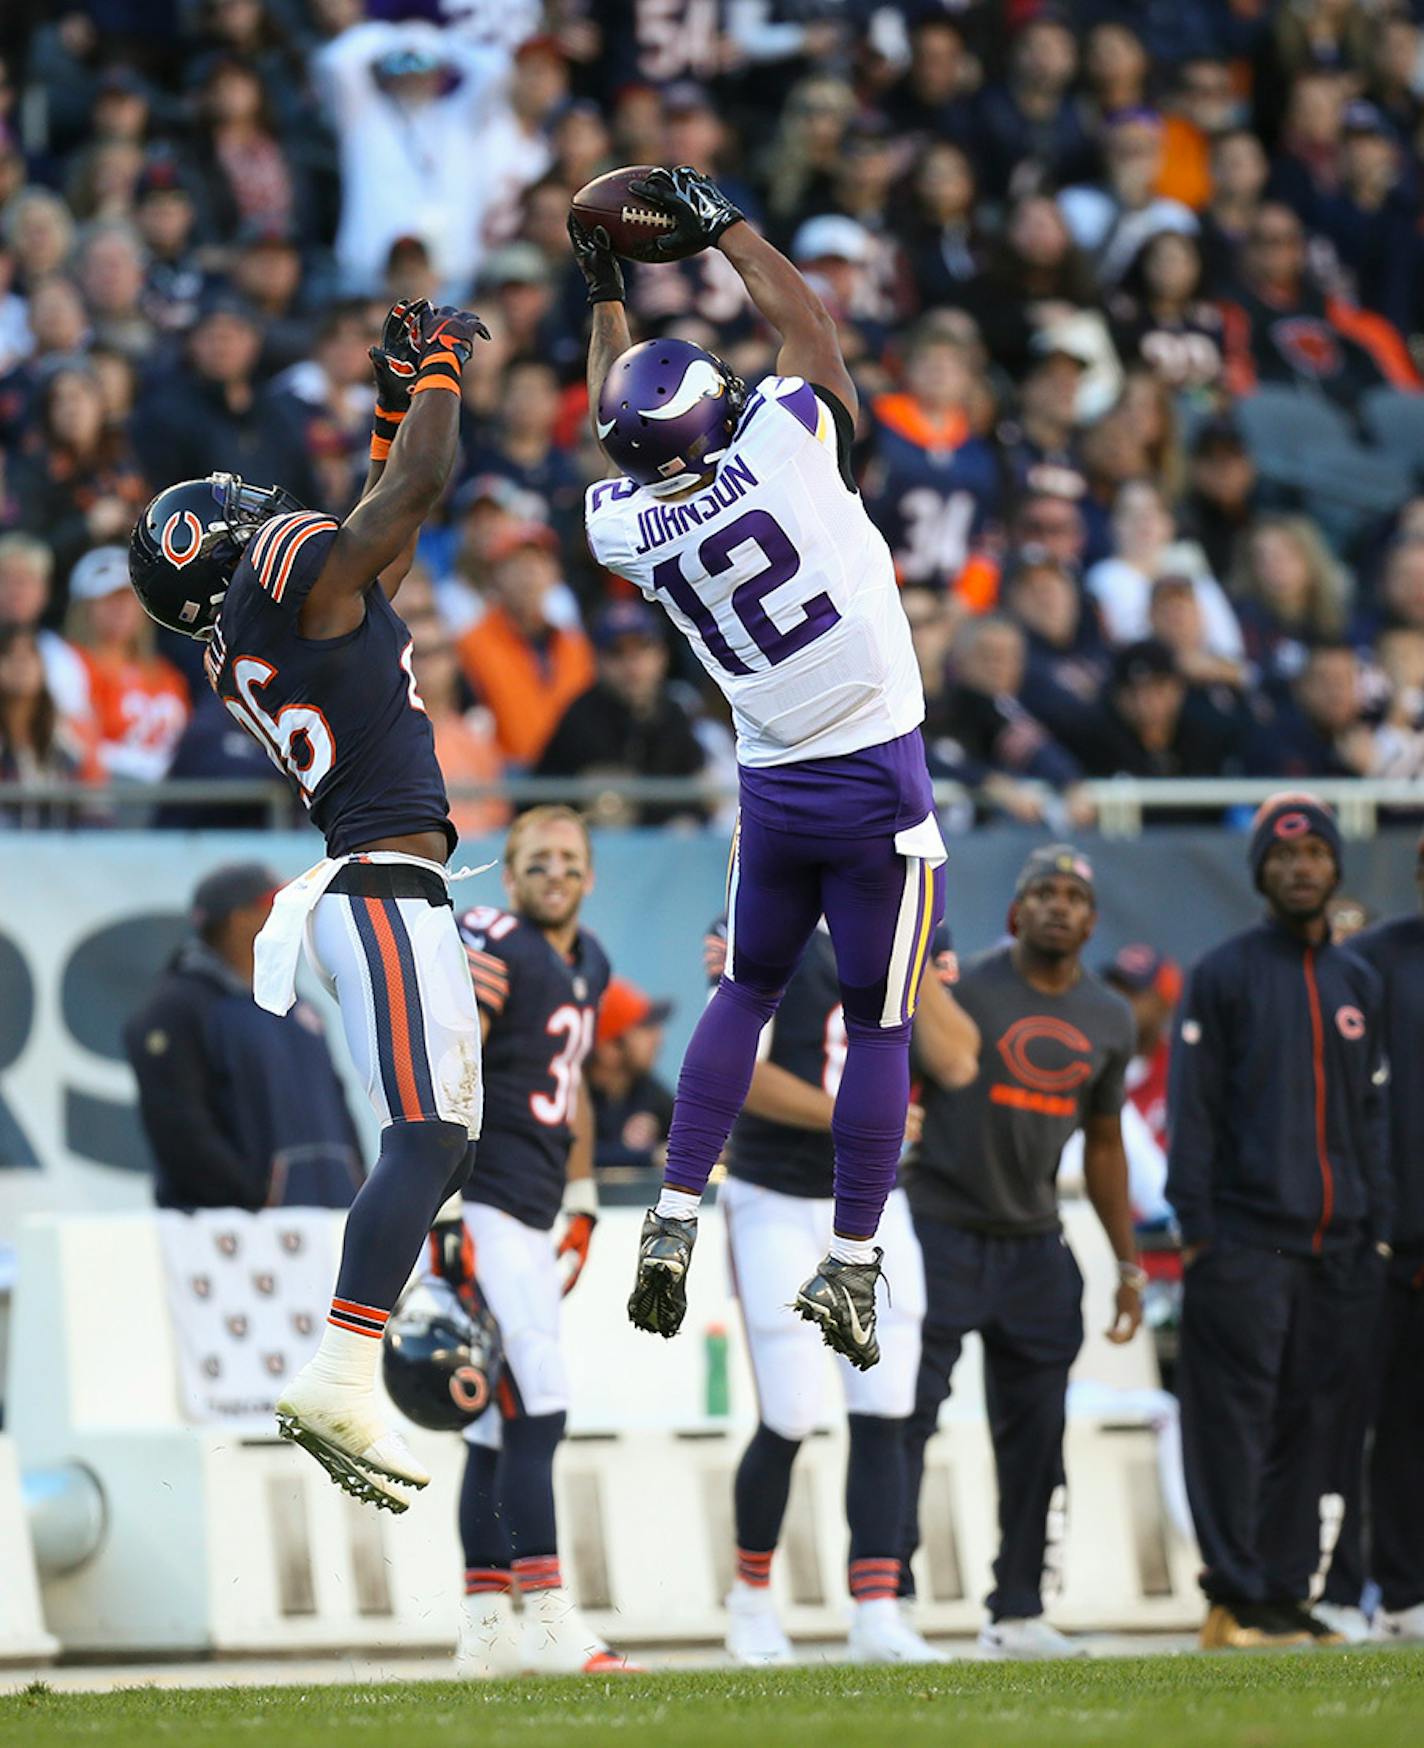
[863,329,999,587]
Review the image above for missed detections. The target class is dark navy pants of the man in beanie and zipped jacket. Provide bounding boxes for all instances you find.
[1178,1238,1380,1603]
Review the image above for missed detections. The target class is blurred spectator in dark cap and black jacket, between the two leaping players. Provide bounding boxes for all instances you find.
[535,601,706,825]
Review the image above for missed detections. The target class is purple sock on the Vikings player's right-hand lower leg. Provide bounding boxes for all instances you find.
[835,1019,910,1238]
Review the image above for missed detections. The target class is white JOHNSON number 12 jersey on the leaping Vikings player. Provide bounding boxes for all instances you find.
[585,376,924,766]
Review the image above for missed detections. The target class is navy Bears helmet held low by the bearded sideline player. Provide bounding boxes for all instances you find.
[381,1278,505,1432]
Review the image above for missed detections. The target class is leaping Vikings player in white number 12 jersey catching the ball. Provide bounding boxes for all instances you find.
[570,166,945,1369]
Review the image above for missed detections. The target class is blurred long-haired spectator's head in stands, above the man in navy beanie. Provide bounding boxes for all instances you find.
[1232,516,1349,694]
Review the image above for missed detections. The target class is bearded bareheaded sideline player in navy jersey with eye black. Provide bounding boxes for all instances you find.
[433,808,627,1675]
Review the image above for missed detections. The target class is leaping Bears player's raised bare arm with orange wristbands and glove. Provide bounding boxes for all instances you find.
[301,309,489,638]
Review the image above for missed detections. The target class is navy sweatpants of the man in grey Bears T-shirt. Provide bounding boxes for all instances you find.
[900,1213,1083,1620]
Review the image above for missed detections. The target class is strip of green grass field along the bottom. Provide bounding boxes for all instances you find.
[0,1650,1424,1748]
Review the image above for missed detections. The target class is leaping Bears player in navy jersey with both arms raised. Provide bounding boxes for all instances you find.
[129,302,487,1512]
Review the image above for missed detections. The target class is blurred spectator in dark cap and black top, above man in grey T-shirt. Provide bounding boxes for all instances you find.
[1064,638,1242,778]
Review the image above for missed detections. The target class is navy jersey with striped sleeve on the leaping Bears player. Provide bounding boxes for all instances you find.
[204,510,456,857]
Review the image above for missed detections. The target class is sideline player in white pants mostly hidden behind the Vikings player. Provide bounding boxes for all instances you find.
[719,918,978,1662]
